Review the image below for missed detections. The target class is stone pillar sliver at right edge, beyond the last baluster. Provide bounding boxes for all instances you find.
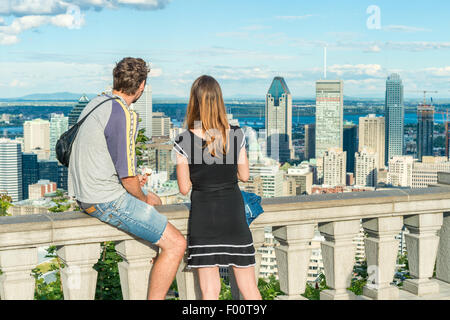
[436,212,450,283]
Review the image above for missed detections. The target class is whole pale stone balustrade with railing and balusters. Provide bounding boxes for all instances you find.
[0,186,450,300]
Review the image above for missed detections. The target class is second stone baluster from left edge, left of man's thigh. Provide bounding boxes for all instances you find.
[57,243,101,300]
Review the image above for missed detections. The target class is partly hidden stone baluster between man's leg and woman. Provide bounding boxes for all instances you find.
[176,255,202,300]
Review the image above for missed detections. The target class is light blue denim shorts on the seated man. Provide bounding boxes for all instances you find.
[85,192,167,243]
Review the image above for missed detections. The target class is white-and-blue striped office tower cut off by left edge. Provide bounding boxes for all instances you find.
[0,138,23,201]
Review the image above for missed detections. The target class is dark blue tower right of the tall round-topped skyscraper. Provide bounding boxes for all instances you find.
[417,104,434,161]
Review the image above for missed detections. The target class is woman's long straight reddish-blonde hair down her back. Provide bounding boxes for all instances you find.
[185,75,229,157]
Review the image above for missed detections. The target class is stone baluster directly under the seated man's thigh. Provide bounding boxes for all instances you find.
[116,240,158,300]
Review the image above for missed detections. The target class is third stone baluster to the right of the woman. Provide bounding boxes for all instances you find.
[363,217,403,300]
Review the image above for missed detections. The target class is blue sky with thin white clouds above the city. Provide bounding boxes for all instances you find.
[0,0,450,99]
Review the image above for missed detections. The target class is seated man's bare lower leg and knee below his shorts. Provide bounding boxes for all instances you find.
[148,222,186,300]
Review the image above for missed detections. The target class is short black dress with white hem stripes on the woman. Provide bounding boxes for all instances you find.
[174,126,255,268]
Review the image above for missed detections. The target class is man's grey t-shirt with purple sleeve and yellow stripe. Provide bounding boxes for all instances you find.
[68,95,138,204]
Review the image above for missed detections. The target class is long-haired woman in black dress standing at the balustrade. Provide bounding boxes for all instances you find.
[174,76,261,300]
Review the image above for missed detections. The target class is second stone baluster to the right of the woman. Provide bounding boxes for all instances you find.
[319,220,360,300]
